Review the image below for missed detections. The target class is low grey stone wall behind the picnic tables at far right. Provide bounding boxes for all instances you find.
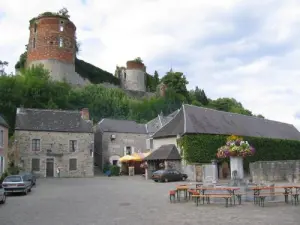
[249,160,300,183]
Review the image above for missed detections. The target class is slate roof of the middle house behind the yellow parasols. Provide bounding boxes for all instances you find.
[97,119,147,134]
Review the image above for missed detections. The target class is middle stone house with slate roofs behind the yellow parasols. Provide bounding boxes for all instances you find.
[95,110,178,169]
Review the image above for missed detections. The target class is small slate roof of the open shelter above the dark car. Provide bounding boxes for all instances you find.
[144,144,181,161]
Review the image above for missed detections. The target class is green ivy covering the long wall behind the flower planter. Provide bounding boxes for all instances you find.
[178,134,300,169]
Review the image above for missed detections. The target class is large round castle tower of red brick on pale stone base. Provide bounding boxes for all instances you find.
[26,13,89,86]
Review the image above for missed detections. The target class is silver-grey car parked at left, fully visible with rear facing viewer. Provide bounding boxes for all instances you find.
[2,174,32,195]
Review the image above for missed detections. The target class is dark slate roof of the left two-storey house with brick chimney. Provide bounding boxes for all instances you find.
[15,108,93,133]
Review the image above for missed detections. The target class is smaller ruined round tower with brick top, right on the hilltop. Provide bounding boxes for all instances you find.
[115,60,146,92]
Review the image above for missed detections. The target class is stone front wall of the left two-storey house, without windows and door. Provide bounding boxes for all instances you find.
[15,130,94,177]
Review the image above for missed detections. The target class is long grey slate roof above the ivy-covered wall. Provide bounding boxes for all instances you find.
[152,104,300,140]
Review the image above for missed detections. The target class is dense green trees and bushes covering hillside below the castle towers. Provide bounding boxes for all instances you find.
[0,66,260,134]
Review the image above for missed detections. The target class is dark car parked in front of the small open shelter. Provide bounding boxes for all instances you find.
[152,169,188,182]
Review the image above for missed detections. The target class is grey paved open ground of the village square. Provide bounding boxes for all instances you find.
[0,176,300,225]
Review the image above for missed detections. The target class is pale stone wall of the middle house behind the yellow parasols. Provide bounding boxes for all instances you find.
[95,131,148,169]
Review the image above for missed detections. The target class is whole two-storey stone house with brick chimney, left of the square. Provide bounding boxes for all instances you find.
[14,108,94,177]
